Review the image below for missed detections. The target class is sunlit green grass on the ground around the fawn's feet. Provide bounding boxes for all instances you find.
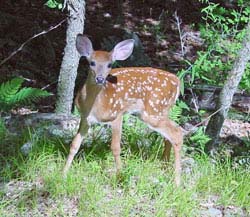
[0,126,250,217]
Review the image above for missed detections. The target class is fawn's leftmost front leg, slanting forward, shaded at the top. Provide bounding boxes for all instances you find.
[63,118,88,175]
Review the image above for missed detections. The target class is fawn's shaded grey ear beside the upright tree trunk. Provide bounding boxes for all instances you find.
[76,34,93,58]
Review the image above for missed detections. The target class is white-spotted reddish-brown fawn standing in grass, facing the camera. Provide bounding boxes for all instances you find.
[64,35,183,186]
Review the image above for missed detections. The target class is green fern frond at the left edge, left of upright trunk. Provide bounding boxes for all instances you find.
[0,78,50,111]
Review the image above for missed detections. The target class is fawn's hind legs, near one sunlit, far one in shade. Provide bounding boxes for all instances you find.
[143,116,183,186]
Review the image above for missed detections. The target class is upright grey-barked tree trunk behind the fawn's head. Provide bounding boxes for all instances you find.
[56,0,85,115]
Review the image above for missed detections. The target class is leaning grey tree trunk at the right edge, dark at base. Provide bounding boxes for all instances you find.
[205,22,250,153]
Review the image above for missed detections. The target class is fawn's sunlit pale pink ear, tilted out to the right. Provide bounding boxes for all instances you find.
[111,39,135,61]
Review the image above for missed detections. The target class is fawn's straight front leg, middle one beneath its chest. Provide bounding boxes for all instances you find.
[111,116,122,174]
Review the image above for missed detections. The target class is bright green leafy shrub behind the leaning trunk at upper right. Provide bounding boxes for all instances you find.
[179,0,250,93]
